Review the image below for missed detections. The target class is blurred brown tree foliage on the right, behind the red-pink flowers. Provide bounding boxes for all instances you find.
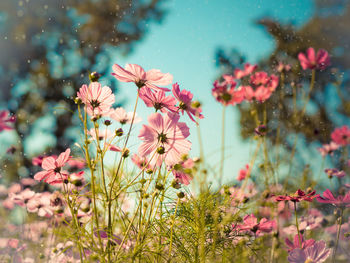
[216,0,350,179]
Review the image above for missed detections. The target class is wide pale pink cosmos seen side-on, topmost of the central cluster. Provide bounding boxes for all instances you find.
[112,64,173,91]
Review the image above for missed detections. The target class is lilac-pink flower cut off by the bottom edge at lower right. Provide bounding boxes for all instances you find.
[288,241,331,263]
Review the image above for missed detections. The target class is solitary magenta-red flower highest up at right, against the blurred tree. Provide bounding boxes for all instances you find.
[298,47,330,70]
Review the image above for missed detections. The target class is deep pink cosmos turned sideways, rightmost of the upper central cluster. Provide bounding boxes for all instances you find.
[172,83,204,122]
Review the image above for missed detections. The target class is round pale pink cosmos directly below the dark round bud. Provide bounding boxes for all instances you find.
[77,82,115,116]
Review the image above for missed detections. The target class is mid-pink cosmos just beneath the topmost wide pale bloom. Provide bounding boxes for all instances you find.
[140,87,178,113]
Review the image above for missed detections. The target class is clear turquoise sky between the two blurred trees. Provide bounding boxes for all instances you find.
[103,0,313,184]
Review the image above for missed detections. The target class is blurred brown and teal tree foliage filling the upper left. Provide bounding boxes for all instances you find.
[0,0,165,183]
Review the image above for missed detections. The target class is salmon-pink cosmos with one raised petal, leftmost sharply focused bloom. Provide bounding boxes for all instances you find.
[34,148,70,184]
